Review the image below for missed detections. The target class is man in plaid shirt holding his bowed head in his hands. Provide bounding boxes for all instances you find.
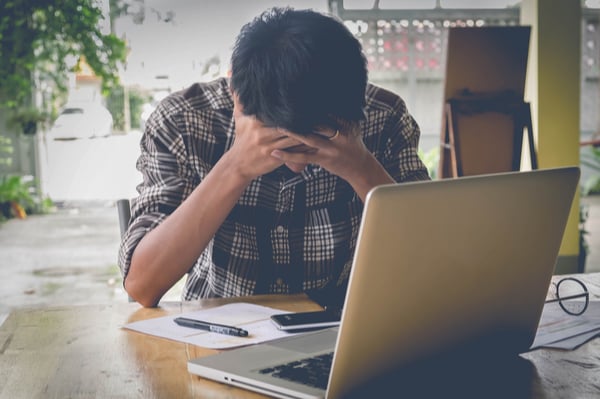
[119,8,429,306]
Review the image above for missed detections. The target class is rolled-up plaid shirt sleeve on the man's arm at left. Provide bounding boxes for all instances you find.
[118,99,197,281]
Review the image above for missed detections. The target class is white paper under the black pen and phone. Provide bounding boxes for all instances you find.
[123,302,304,349]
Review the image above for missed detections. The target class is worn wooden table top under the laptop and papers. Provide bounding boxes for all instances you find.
[0,273,600,399]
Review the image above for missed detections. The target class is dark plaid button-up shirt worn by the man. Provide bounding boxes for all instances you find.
[119,79,429,300]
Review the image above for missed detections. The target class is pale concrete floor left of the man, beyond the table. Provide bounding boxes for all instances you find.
[0,201,181,324]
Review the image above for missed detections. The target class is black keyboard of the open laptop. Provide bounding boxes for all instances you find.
[259,352,333,389]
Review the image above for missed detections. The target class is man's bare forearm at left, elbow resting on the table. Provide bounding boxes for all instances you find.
[125,152,250,307]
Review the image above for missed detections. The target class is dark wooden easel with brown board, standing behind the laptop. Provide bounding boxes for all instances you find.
[438,26,537,178]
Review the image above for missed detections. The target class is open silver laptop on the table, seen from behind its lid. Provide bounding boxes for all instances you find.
[188,167,579,398]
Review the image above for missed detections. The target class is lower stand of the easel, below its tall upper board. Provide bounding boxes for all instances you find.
[438,91,537,178]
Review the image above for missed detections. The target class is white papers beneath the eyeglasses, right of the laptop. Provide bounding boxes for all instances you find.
[531,301,600,350]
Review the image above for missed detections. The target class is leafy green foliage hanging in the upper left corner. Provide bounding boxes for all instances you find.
[0,0,126,126]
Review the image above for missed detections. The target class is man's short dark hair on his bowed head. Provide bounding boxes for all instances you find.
[231,8,367,134]
